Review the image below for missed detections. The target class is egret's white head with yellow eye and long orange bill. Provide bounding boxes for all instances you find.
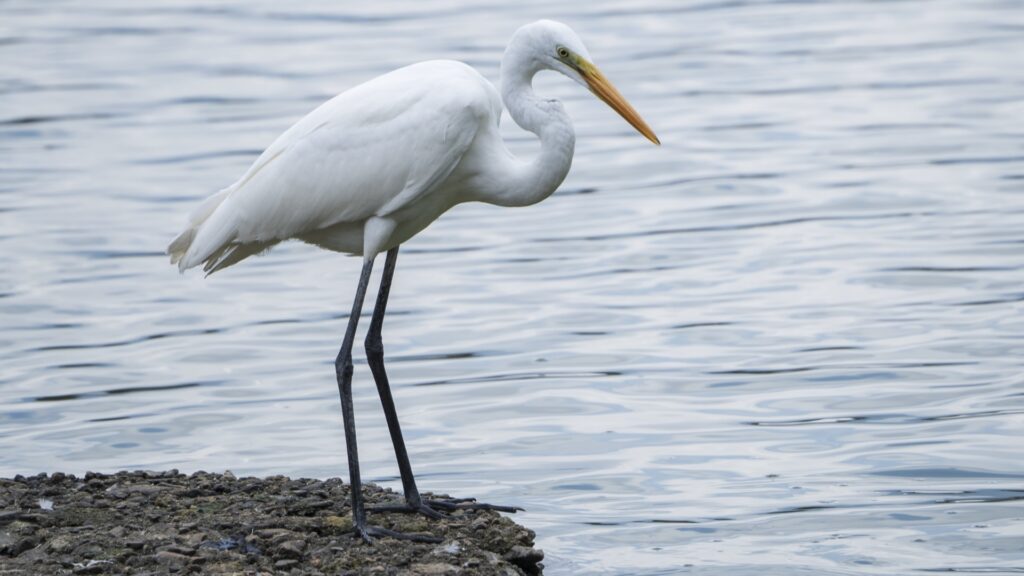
[513,19,662,145]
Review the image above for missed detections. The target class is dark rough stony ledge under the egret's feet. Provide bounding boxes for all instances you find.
[0,470,544,576]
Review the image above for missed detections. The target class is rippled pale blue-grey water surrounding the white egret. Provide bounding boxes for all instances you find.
[0,0,1024,575]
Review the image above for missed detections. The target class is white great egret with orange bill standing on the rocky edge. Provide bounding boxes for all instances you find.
[167,20,660,541]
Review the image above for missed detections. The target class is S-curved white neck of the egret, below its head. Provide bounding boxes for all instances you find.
[486,43,575,206]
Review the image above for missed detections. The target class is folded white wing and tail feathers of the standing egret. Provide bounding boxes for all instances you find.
[169,61,501,270]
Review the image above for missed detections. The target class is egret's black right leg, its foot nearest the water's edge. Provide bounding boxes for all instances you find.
[366,246,520,519]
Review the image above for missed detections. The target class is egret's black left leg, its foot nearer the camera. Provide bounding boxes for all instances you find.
[334,258,440,542]
